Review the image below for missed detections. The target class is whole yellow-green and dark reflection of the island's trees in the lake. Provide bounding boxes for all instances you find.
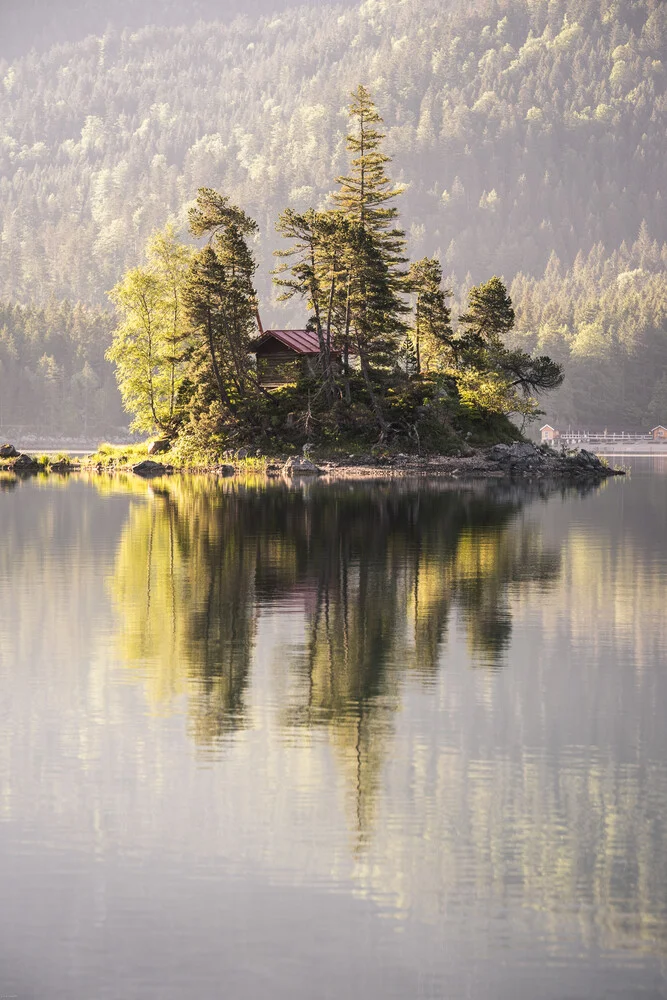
[111,479,560,758]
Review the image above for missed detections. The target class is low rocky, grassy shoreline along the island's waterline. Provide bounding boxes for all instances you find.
[0,442,625,481]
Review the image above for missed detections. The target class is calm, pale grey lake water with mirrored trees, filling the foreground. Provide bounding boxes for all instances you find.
[0,460,667,1000]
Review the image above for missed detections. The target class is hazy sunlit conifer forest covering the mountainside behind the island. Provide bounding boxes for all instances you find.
[0,0,667,428]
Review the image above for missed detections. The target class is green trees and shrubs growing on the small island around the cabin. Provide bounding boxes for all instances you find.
[98,87,562,459]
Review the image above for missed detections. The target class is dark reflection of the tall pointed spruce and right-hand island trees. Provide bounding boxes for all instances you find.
[258,484,560,846]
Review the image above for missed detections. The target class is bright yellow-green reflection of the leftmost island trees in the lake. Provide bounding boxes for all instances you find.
[112,481,257,745]
